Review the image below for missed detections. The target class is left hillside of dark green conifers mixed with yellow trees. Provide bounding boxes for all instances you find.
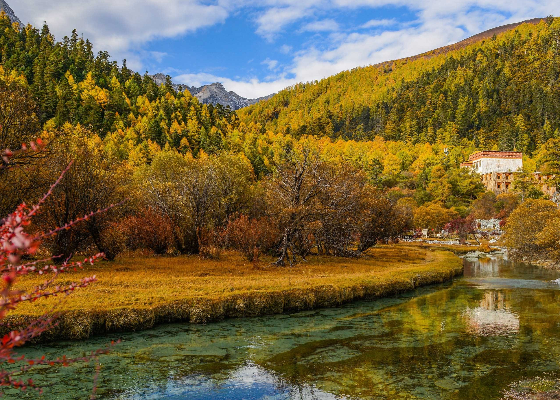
[0,18,235,154]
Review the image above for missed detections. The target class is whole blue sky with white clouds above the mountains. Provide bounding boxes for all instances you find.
[7,0,560,98]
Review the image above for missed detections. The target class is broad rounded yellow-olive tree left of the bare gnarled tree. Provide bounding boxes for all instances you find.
[137,149,254,254]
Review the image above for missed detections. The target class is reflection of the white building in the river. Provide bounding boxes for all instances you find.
[464,291,519,336]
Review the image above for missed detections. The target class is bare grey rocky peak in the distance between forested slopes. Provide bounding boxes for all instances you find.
[152,73,273,110]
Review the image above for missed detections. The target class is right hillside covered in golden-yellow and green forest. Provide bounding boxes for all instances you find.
[240,18,560,153]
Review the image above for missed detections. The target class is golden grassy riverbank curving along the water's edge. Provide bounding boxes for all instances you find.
[2,245,463,340]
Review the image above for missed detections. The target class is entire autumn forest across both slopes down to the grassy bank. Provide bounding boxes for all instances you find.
[0,13,560,265]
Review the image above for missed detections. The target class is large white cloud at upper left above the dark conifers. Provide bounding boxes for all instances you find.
[13,0,229,62]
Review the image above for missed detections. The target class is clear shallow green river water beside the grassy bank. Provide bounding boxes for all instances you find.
[5,255,560,400]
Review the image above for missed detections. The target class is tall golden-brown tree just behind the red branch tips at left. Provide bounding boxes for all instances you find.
[36,125,130,261]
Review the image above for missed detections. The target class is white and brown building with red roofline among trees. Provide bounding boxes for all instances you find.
[461,151,558,199]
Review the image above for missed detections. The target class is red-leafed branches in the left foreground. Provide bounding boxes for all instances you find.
[0,152,114,390]
